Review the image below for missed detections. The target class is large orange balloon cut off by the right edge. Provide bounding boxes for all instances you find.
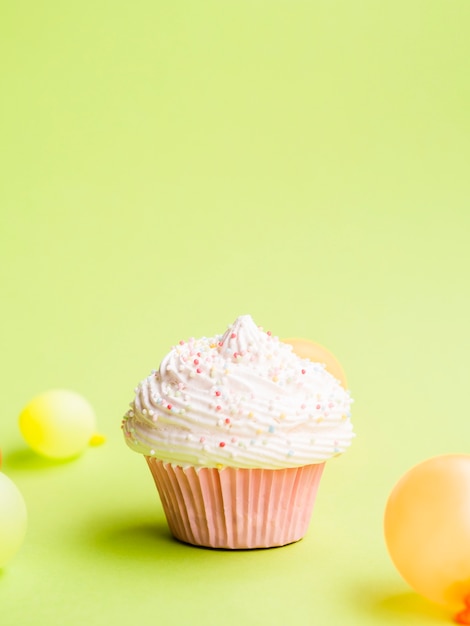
[384,454,470,624]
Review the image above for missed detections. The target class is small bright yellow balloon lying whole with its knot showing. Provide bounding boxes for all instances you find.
[19,389,103,459]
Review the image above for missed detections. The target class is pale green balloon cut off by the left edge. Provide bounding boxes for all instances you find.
[0,472,27,568]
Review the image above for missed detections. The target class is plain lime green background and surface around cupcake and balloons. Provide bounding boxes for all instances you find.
[0,0,470,626]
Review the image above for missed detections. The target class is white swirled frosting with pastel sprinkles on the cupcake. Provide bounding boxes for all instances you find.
[122,315,354,469]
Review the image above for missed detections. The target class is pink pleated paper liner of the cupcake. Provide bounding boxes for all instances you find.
[145,457,325,550]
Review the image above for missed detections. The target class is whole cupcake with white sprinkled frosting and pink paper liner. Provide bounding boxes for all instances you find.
[122,315,353,549]
